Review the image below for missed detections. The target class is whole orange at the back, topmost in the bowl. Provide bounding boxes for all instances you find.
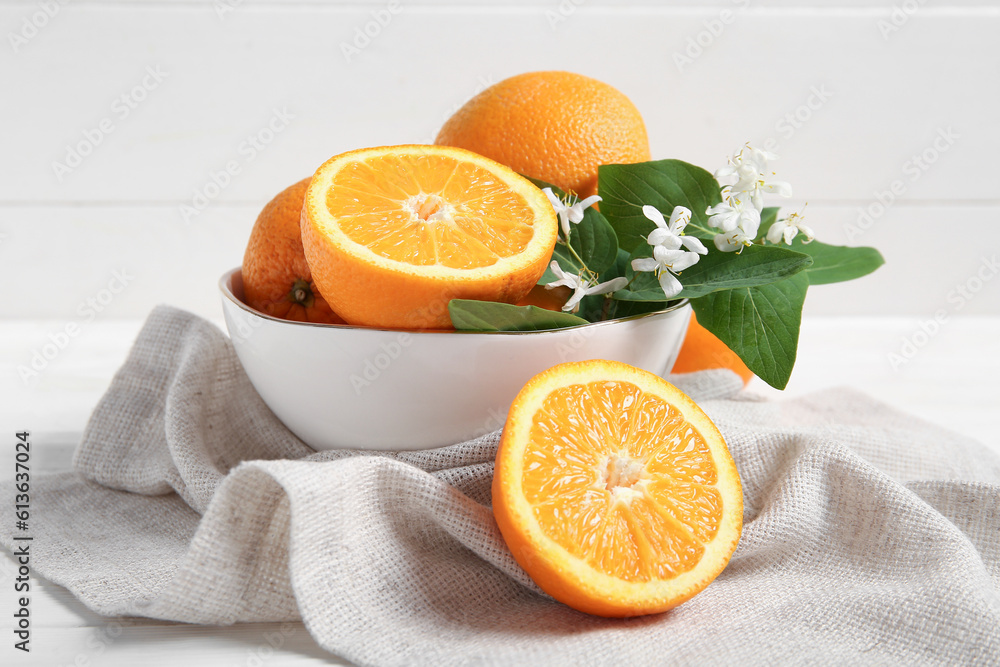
[434,72,650,198]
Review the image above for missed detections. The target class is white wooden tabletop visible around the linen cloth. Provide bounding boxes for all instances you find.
[0,316,1000,667]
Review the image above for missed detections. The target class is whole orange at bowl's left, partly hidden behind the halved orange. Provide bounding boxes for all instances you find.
[243,178,344,324]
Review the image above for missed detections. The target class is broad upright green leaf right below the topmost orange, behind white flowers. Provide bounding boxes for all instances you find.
[597,160,722,252]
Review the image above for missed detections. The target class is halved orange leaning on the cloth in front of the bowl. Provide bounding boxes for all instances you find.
[493,360,743,616]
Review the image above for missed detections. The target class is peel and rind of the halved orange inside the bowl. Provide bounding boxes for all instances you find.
[301,146,558,331]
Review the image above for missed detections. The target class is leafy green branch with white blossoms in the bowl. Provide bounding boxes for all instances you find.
[449,155,884,388]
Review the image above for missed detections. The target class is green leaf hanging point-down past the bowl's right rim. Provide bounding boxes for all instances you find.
[691,272,809,389]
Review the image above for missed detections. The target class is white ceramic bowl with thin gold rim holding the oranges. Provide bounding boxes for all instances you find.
[219,269,691,450]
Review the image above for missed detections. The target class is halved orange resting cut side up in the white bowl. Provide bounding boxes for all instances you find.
[302,146,557,329]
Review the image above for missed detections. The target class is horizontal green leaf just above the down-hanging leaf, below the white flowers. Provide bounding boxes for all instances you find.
[677,245,813,299]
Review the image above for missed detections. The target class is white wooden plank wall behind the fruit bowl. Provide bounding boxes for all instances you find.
[0,0,1000,321]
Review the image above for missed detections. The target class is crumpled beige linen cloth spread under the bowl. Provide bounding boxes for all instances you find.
[0,307,1000,665]
